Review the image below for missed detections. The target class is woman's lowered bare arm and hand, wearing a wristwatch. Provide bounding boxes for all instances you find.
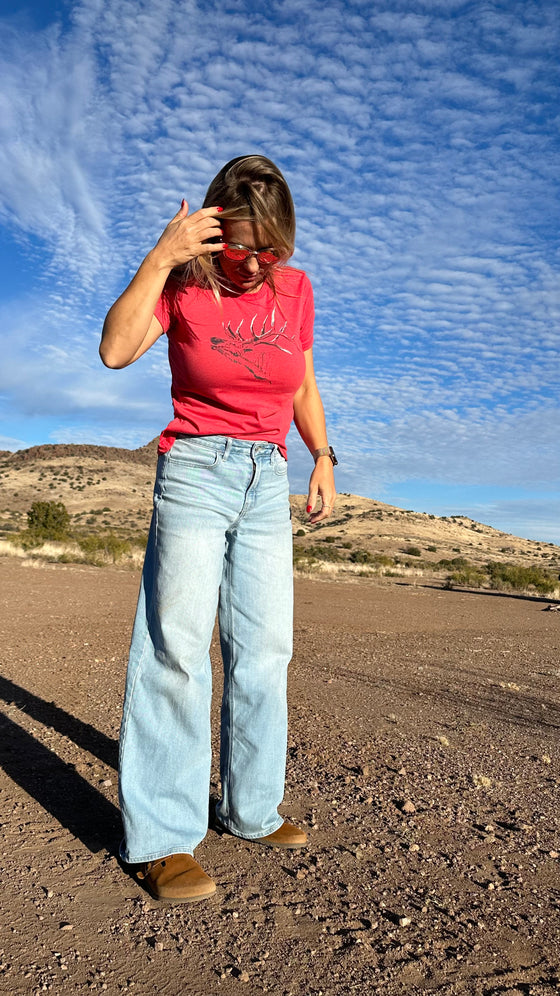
[294,349,336,524]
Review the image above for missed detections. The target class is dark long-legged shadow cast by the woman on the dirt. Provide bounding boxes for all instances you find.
[0,677,122,855]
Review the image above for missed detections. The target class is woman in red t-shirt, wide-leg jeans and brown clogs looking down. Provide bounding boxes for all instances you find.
[100,156,335,901]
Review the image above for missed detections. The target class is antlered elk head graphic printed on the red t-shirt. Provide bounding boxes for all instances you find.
[210,308,295,382]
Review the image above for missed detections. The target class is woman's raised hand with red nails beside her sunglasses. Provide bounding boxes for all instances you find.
[151,201,226,271]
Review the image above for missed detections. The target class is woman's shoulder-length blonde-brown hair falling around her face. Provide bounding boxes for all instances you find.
[174,156,296,300]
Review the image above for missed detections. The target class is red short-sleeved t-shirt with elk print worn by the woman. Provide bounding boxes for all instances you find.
[154,267,314,456]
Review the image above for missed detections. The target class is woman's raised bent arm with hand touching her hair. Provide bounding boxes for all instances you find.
[99,201,224,368]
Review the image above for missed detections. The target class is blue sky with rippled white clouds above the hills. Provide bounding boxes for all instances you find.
[0,0,560,542]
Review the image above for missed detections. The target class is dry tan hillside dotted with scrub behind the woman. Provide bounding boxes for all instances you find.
[0,440,560,572]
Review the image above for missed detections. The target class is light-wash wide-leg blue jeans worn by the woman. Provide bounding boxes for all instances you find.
[119,436,293,863]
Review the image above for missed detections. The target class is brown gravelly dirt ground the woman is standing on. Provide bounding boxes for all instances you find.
[0,559,560,996]
